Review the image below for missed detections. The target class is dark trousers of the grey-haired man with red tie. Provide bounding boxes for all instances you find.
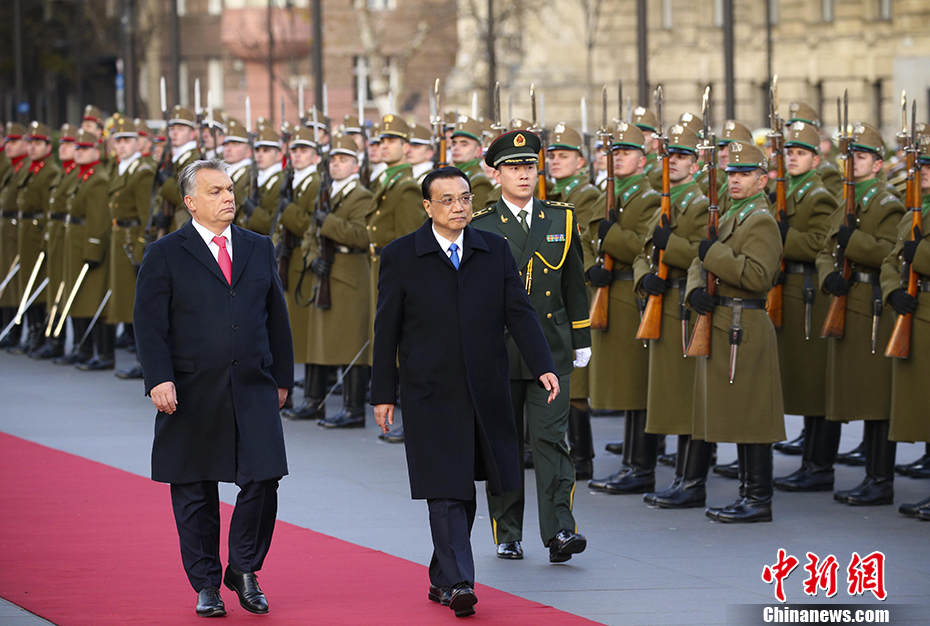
[171,428,279,592]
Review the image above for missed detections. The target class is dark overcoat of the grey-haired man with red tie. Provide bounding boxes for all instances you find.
[133,223,294,483]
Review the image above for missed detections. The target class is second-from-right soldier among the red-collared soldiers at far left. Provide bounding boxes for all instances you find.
[29,123,78,359]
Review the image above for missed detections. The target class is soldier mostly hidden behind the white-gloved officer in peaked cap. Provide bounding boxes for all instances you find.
[546,123,601,480]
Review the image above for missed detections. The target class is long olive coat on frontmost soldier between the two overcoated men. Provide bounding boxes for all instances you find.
[295,180,372,365]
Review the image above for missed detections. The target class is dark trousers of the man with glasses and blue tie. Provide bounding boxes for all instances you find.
[426,494,477,587]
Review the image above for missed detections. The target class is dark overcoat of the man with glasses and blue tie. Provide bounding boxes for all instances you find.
[371,221,556,500]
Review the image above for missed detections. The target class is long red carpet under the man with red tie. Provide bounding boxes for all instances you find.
[0,433,593,626]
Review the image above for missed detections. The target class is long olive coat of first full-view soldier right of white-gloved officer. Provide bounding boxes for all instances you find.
[585,177,662,411]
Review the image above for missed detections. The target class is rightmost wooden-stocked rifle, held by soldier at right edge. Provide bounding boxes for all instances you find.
[885,100,923,359]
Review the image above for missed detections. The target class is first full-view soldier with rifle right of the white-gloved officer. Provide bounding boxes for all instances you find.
[585,122,662,494]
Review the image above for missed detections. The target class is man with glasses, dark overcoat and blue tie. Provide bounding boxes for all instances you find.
[371,167,559,616]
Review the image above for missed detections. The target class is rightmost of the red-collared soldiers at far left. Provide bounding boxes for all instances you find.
[61,130,113,369]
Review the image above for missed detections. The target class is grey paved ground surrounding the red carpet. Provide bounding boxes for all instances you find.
[0,351,930,626]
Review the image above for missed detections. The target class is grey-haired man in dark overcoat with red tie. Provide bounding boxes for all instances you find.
[133,160,294,616]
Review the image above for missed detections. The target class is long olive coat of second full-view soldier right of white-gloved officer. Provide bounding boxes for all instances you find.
[633,183,708,435]
